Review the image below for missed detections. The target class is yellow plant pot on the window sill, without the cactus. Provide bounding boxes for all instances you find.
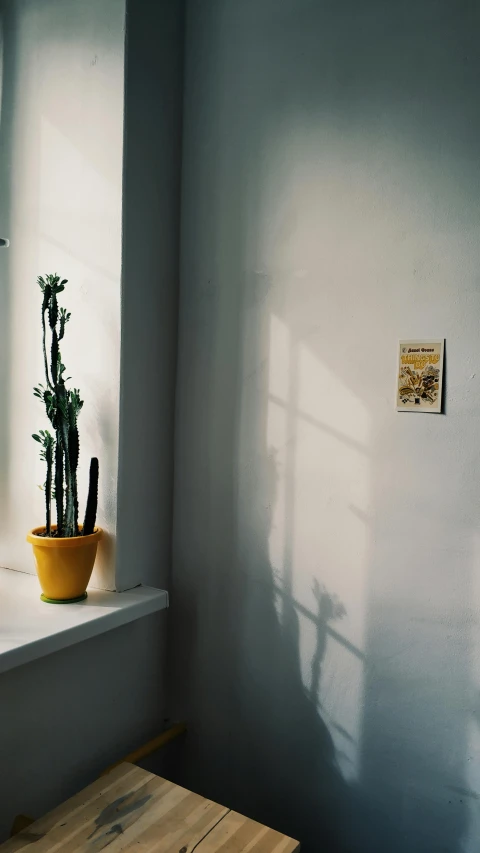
[27,526,102,603]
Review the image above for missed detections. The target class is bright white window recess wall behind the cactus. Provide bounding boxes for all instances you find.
[0,0,125,588]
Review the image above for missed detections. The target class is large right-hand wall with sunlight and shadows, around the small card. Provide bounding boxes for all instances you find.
[172,0,480,853]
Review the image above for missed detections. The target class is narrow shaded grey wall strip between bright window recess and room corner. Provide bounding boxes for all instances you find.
[116,0,183,589]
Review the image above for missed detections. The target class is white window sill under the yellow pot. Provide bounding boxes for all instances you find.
[0,568,168,673]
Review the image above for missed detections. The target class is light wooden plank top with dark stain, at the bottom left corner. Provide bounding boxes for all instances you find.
[0,763,300,853]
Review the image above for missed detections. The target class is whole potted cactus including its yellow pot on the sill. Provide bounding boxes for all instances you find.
[27,274,102,604]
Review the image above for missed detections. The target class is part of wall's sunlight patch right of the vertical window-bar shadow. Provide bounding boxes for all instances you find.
[293,343,370,778]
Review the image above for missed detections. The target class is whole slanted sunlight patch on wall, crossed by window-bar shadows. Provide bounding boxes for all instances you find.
[267,315,370,779]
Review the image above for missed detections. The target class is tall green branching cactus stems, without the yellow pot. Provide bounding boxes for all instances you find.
[33,273,98,537]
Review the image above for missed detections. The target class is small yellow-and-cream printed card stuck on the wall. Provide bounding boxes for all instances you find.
[397,339,445,414]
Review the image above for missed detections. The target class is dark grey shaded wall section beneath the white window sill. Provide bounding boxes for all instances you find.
[0,613,166,841]
